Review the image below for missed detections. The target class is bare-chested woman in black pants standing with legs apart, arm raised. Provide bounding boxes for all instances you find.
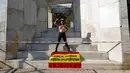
[55,19,70,52]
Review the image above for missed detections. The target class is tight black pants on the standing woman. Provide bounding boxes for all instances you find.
[55,32,70,51]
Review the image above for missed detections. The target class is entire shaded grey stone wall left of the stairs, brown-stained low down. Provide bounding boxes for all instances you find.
[7,0,48,59]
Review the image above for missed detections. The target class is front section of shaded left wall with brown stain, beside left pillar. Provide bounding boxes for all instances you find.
[6,0,37,59]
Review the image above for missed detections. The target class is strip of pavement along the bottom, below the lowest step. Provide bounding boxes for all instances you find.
[0,68,130,73]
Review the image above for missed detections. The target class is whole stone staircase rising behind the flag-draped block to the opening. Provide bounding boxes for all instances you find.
[7,28,121,69]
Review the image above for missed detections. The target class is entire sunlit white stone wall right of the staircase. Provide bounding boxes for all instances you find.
[80,0,122,62]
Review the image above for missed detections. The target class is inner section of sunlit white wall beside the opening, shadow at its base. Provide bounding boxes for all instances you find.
[80,0,100,41]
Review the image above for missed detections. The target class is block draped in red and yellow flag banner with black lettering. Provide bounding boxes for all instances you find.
[48,52,81,68]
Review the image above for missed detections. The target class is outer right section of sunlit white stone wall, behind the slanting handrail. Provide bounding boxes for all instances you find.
[99,0,123,62]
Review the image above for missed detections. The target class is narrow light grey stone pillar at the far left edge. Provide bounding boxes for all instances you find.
[0,0,8,67]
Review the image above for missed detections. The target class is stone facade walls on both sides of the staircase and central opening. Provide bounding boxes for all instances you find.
[0,0,130,69]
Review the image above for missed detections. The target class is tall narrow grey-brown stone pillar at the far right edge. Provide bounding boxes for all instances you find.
[119,0,130,69]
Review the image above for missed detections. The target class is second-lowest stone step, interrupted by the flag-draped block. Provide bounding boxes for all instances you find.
[17,51,108,60]
